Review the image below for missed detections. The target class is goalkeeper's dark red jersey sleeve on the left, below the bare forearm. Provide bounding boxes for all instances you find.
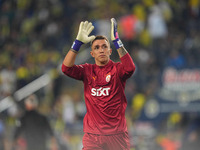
[62,64,84,80]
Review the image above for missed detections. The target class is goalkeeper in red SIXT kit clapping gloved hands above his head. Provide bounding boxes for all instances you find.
[62,18,135,150]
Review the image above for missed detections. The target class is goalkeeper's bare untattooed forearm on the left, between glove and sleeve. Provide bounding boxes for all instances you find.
[63,49,77,67]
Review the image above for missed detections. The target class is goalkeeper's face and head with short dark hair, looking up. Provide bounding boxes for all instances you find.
[90,39,112,66]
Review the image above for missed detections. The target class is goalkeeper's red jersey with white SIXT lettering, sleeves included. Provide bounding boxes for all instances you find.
[62,53,135,135]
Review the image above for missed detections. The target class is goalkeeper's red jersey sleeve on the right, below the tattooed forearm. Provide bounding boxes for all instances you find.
[118,53,135,80]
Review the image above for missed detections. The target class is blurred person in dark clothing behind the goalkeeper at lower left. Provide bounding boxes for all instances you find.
[13,95,56,150]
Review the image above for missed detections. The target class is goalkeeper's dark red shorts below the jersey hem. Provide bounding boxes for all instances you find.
[82,132,130,150]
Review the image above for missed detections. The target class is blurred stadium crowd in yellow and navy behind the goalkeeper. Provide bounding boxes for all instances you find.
[0,0,200,150]
